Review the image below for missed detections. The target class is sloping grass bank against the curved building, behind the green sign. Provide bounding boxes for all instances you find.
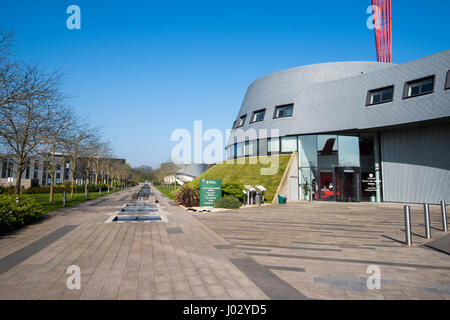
[188,154,291,201]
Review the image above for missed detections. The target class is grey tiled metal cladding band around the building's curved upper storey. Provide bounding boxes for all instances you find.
[228,50,450,144]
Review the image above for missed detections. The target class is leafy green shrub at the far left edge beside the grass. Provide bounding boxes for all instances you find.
[0,195,44,233]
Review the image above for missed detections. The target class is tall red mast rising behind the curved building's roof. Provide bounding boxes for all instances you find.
[372,0,392,63]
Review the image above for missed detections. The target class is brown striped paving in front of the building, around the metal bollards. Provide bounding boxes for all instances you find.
[195,202,450,299]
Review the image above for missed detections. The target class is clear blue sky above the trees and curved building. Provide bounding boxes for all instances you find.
[0,0,450,167]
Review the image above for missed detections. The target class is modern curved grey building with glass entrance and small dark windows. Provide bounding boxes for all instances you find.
[226,50,450,203]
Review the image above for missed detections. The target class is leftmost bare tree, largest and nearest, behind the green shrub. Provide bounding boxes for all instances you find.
[0,33,62,194]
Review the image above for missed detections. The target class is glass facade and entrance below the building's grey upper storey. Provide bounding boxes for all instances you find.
[227,133,382,202]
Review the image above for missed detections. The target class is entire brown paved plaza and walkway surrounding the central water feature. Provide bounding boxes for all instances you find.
[0,188,450,299]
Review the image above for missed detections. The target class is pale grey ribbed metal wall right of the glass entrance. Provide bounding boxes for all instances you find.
[380,122,450,203]
